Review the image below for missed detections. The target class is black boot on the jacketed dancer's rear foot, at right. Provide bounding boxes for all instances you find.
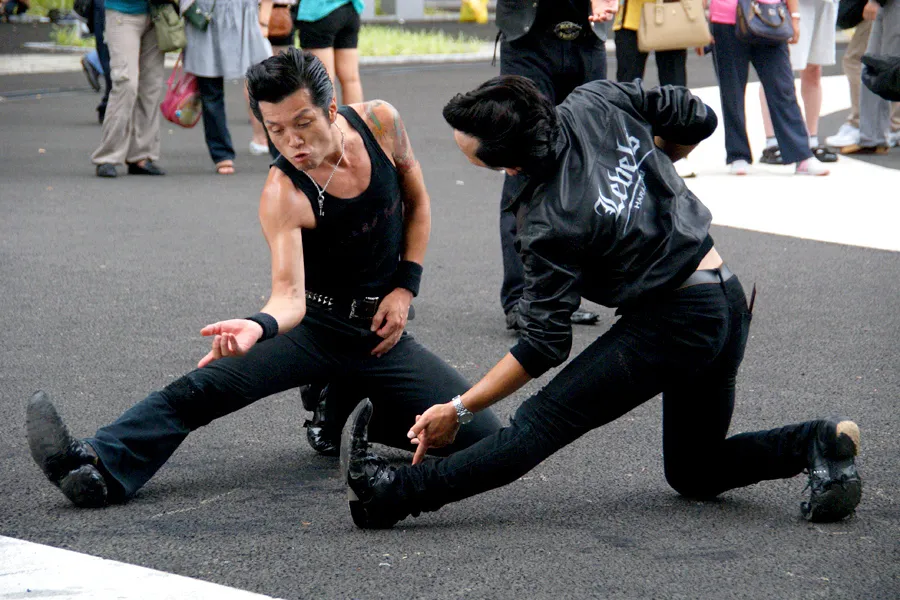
[800,418,862,523]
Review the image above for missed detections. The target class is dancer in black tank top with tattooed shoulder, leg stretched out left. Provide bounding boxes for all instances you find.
[27,49,500,507]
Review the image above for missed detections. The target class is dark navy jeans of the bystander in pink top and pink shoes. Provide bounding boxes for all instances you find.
[710,23,812,164]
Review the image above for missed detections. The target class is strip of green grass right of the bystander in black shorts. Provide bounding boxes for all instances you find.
[359,25,483,56]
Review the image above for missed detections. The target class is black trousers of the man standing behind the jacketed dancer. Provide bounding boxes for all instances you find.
[500,31,606,312]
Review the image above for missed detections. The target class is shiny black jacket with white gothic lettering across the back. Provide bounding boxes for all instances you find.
[504,81,717,377]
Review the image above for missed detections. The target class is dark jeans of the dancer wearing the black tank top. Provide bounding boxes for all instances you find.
[86,313,500,501]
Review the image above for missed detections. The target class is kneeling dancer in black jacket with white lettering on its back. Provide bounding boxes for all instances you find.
[341,77,862,527]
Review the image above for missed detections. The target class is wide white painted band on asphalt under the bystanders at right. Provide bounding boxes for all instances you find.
[685,76,900,251]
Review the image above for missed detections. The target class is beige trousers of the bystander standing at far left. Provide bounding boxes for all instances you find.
[91,10,165,165]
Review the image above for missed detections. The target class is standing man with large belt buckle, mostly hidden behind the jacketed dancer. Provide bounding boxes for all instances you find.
[497,0,619,330]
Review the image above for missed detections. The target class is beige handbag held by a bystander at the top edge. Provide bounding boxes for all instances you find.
[638,0,712,52]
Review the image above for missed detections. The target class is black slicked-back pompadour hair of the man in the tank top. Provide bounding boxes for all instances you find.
[247,47,334,122]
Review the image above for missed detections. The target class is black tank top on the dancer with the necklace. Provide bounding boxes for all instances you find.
[274,106,403,298]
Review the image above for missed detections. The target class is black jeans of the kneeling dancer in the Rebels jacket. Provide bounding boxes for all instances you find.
[385,277,815,514]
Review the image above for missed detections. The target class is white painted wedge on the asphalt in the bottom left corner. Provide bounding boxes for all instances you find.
[0,536,284,600]
